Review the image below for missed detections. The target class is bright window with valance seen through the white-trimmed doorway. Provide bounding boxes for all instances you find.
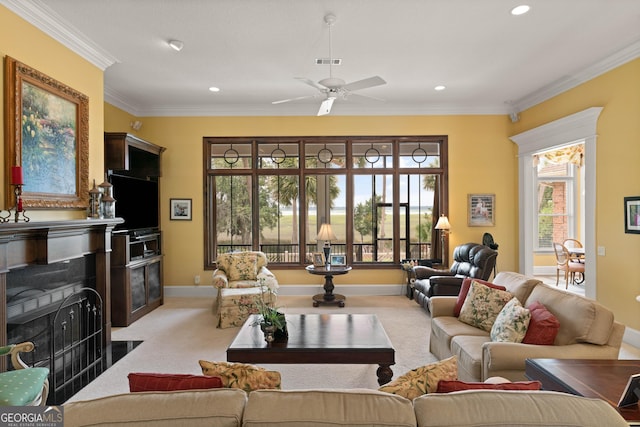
[534,144,583,251]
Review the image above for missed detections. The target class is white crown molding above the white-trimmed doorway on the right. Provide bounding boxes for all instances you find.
[512,40,640,112]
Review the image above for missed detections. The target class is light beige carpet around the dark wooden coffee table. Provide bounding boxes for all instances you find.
[69,296,436,401]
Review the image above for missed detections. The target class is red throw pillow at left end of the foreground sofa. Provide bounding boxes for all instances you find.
[128,372,222,393]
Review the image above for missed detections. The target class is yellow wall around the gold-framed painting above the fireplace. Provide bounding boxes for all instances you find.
[0,6,104,221]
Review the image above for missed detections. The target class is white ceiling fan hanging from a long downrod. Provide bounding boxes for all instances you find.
[272,14,387,116]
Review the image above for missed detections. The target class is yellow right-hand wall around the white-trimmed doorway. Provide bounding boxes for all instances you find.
[510,59,640,330]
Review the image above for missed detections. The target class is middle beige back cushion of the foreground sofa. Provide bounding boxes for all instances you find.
[243,389,416,427]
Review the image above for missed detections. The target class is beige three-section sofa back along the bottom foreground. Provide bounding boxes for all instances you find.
[64,389,628,427]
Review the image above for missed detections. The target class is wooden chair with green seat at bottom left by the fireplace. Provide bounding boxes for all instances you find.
[0,342,49,406]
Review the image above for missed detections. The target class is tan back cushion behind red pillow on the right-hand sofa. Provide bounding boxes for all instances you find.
[525,285,613,345]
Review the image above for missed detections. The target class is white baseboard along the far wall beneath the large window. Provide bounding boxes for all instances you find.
[164,284,406,298]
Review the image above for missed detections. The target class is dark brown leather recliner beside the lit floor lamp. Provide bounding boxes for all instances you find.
[413,243,498,310]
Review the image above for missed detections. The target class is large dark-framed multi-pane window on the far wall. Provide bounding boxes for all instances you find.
[204,136,448,268]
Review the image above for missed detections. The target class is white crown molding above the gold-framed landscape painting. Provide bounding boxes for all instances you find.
[0,0,120,71]
